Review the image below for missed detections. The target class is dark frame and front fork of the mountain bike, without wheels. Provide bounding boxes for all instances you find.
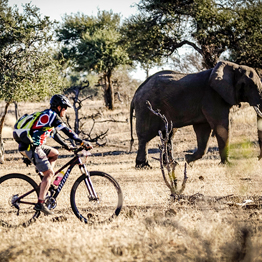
[12,148,99,206]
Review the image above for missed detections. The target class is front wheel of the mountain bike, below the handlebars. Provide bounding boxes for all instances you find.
[70,171,123,224]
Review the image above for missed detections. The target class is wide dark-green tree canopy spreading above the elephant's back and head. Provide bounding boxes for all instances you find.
[123,0,261,68]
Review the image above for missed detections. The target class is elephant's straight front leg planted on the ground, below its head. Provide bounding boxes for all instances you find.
[214,125,229,164]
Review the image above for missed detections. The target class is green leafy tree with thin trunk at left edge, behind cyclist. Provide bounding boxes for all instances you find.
[0,0,62,163]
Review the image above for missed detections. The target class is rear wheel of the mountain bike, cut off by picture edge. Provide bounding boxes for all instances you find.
[0,173,40,227]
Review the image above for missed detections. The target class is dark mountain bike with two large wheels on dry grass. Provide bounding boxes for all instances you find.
[0,146,123,227]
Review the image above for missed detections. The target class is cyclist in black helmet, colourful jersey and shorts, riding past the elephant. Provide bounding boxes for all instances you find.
[14,94,92,215]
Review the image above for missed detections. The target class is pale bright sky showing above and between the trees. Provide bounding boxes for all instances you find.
[8,0,164,80]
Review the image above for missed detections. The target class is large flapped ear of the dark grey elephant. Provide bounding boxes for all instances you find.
[209,62,237,105]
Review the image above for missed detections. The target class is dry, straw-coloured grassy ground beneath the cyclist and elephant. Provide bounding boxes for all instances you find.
[0,101,262,261]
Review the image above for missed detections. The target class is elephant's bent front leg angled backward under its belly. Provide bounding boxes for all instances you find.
[185,123,211,163]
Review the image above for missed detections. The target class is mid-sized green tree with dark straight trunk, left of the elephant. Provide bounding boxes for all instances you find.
[57,11,129,109]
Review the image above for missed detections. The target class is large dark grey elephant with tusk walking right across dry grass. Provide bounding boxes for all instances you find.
[130,61,262,167]
